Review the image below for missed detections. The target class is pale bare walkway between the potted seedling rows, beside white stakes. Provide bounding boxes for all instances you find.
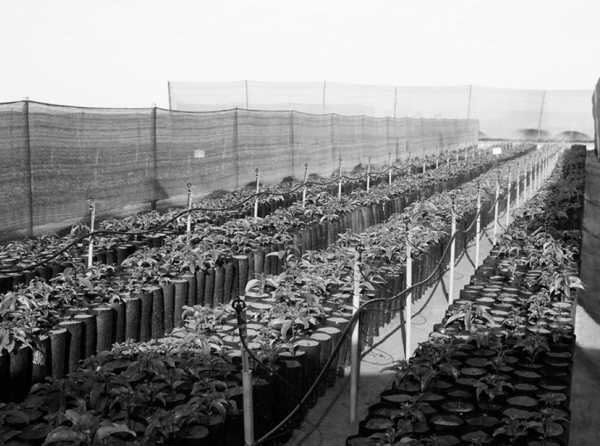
[287,206,516,446]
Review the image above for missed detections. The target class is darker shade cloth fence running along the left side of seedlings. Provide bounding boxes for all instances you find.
[0,101,479,238]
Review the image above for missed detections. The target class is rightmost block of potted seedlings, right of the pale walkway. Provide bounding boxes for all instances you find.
[347,145,585,446]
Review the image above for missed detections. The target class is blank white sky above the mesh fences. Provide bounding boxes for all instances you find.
[0,0,600,107]
